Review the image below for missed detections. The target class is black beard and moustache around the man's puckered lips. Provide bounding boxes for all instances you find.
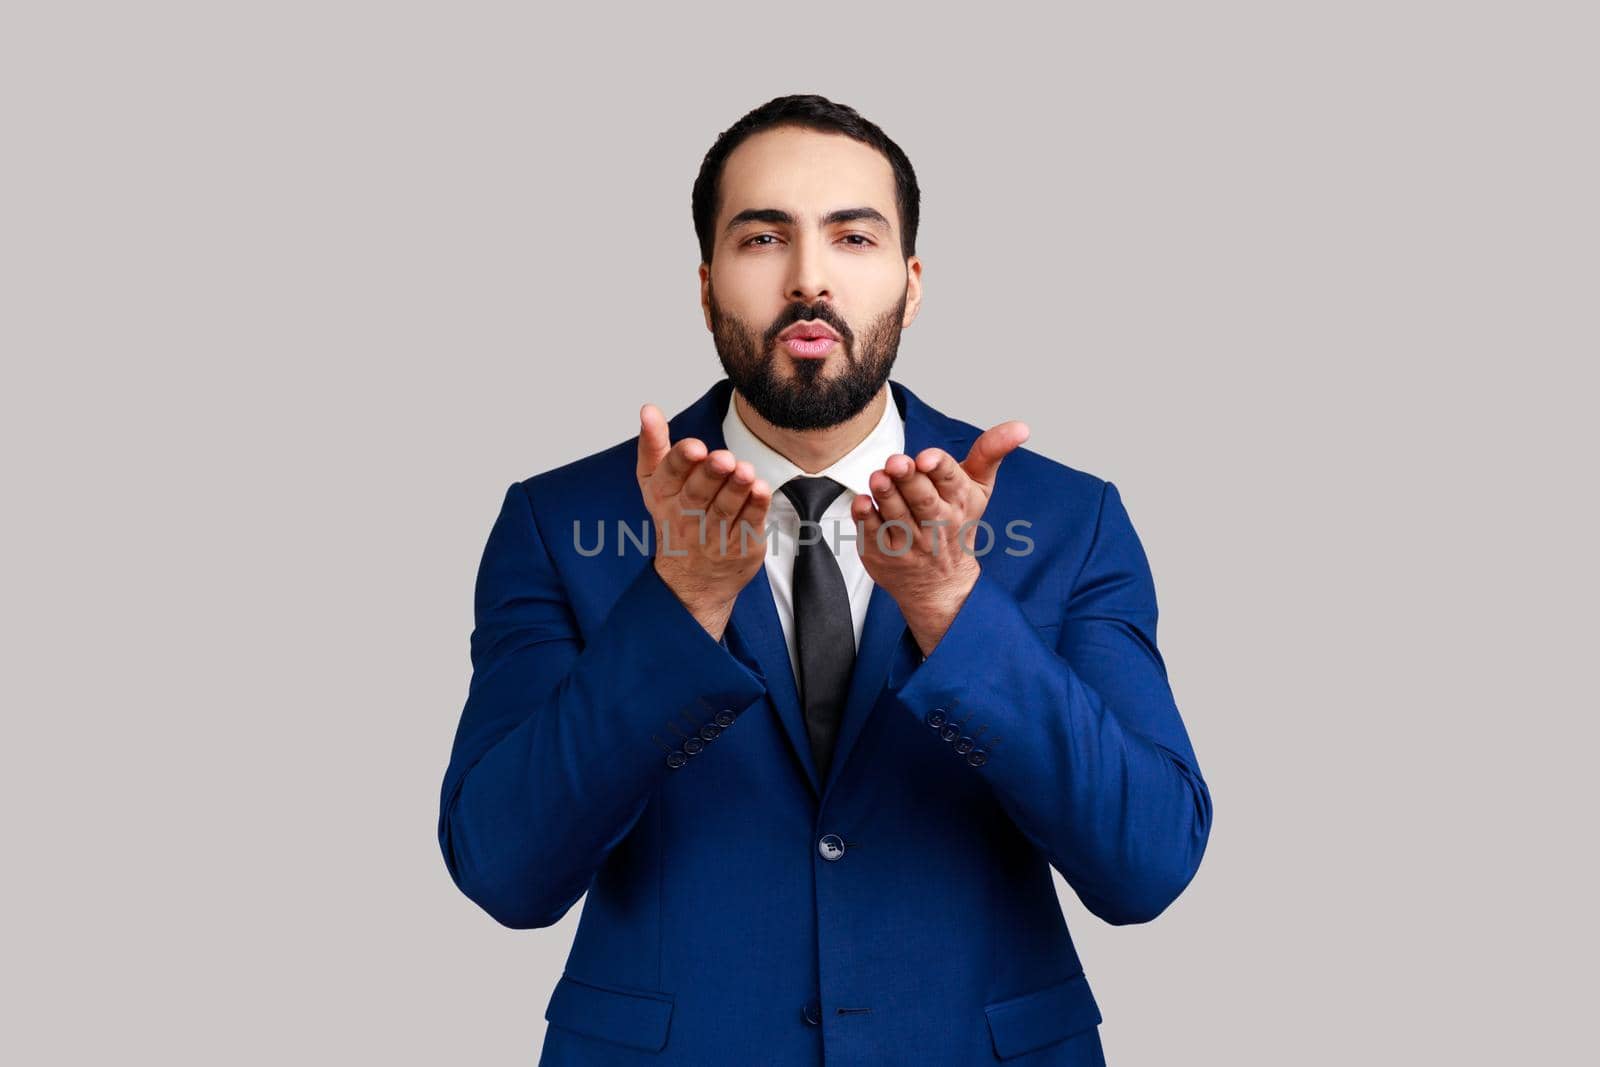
[709,293,906,430]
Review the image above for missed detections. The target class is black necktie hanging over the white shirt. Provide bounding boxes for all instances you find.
[779,477,856,781]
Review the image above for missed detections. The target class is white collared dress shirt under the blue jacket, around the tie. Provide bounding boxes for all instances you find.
[722,382,906,683]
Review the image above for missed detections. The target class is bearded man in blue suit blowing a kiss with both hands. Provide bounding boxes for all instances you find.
[438,96,1211,1067]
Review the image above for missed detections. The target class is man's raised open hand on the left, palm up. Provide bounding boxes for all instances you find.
[638,403,773,640]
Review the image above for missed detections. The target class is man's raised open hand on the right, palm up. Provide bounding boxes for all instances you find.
[850,421,1029,656]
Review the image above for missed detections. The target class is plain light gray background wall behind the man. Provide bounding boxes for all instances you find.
[0,0,1600,1065]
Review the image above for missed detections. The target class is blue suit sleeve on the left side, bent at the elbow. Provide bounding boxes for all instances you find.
[438,483,766,929]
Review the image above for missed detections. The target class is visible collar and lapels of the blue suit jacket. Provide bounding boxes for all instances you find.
[669,378,965,798]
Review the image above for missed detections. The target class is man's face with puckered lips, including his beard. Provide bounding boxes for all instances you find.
[701,128,922,430]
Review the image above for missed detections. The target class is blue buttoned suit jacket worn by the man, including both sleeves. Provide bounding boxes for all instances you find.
[438,379,1211,1067]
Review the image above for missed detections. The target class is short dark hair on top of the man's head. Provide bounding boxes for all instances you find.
[690,93,922,264]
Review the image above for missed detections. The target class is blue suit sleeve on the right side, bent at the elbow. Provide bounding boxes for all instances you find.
[896,482,1211,925]
